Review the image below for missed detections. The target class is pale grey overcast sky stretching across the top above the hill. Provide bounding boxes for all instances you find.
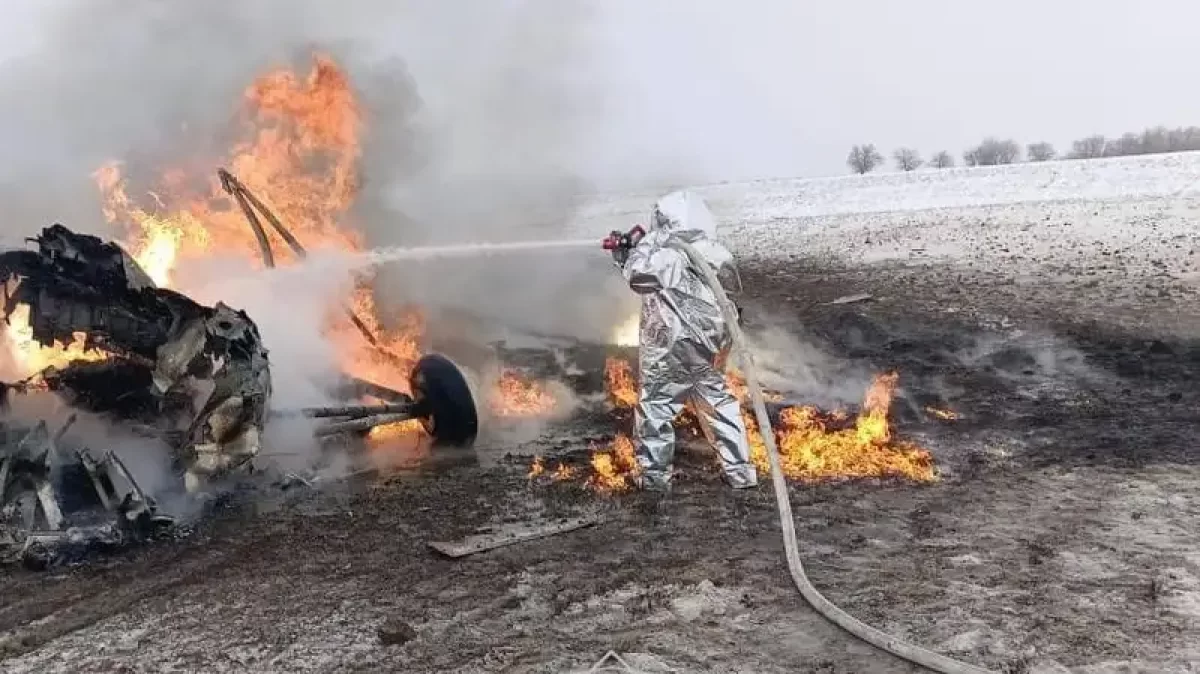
[0,0,1200,193]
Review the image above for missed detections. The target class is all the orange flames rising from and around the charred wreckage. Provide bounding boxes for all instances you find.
[6,55,549,439]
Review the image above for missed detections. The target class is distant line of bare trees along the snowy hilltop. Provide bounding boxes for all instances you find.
[846,126,1200,174]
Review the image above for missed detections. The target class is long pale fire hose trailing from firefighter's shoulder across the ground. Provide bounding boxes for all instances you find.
[672,239,992,674]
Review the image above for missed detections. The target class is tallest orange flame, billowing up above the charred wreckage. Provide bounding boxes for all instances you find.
[94,54,364,280]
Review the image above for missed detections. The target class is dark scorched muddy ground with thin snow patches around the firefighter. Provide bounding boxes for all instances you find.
[0,251,1200,674]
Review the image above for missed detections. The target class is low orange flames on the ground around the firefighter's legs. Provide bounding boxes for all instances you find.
[530,359,936,493]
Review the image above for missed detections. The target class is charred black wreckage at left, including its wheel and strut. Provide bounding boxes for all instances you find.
[0,224,478,566]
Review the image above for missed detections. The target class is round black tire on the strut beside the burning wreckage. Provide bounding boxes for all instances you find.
[409,354,479,447]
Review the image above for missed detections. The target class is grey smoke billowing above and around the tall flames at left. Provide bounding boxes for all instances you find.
[0,0,667,338]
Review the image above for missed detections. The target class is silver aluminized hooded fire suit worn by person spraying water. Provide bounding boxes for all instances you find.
[616,192,757,489]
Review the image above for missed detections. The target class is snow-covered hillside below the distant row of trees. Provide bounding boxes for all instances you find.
[574,152,1200,268]
